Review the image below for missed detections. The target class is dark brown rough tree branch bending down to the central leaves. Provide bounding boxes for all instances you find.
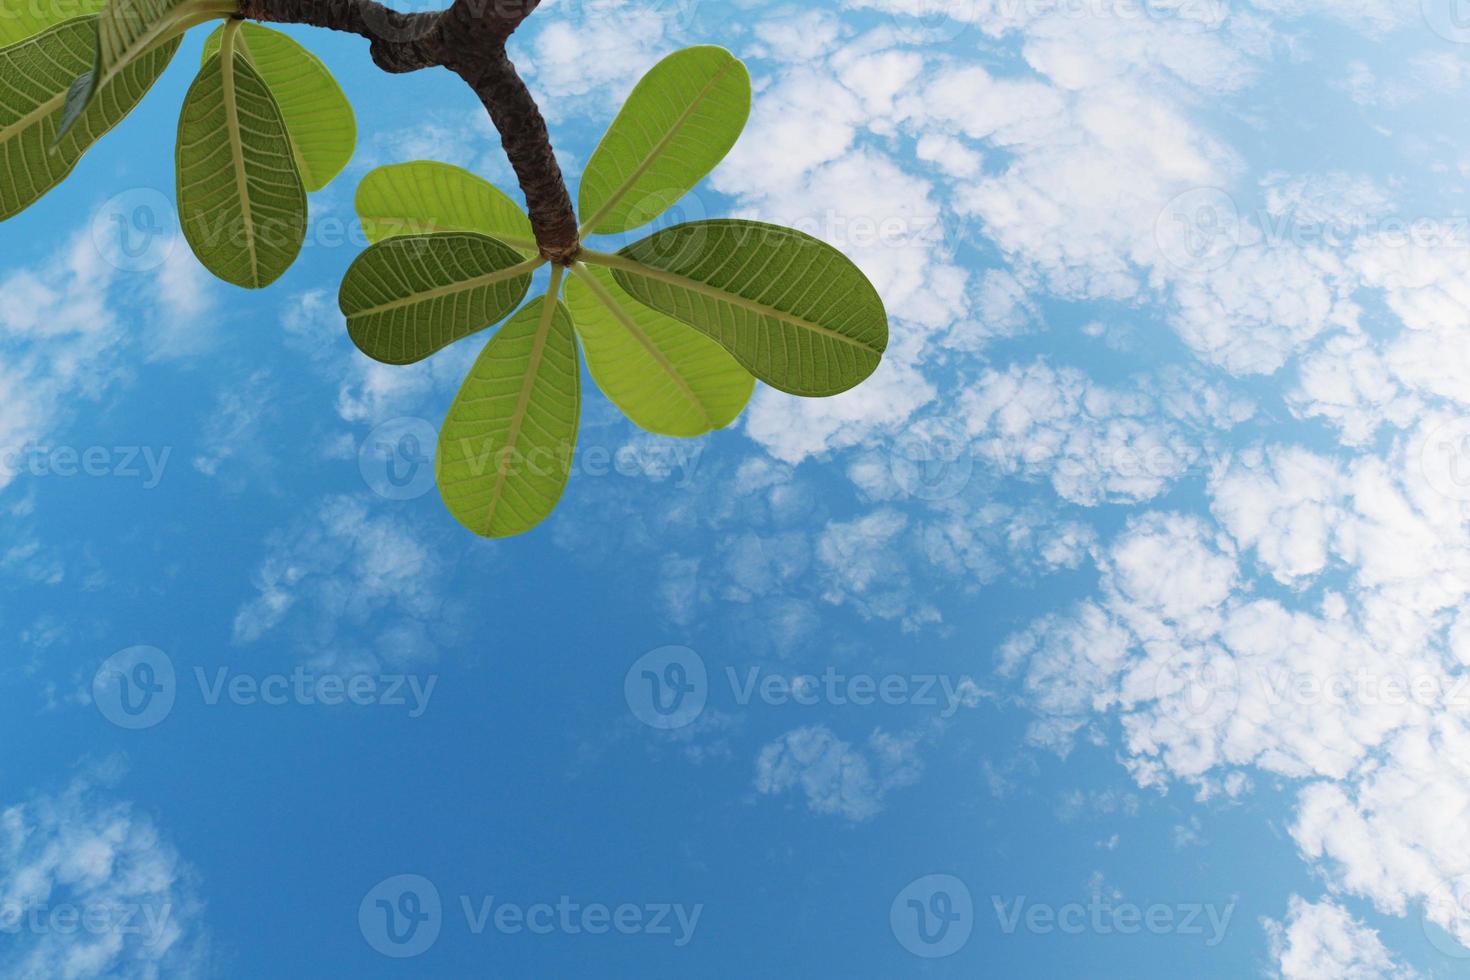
[240,0,578,264]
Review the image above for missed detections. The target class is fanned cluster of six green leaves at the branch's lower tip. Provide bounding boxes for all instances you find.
[340,47,888,536]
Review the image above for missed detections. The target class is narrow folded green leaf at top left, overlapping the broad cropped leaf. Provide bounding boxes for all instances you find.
[57,0,230,138]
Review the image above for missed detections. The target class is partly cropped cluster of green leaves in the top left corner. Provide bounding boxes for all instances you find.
[0,0,357,274]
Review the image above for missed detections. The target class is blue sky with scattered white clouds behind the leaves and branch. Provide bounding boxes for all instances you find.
[0,0,1470,980]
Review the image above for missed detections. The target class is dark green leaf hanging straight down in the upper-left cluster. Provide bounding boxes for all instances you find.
[176,21,306,289]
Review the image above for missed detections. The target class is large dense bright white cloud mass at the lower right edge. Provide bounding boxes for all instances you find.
[1003,417,1470,940]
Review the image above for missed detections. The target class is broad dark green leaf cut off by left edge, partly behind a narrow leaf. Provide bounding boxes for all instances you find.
[0,18,178,219]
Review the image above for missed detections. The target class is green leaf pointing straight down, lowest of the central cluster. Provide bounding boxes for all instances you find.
[434,283,581,538]
